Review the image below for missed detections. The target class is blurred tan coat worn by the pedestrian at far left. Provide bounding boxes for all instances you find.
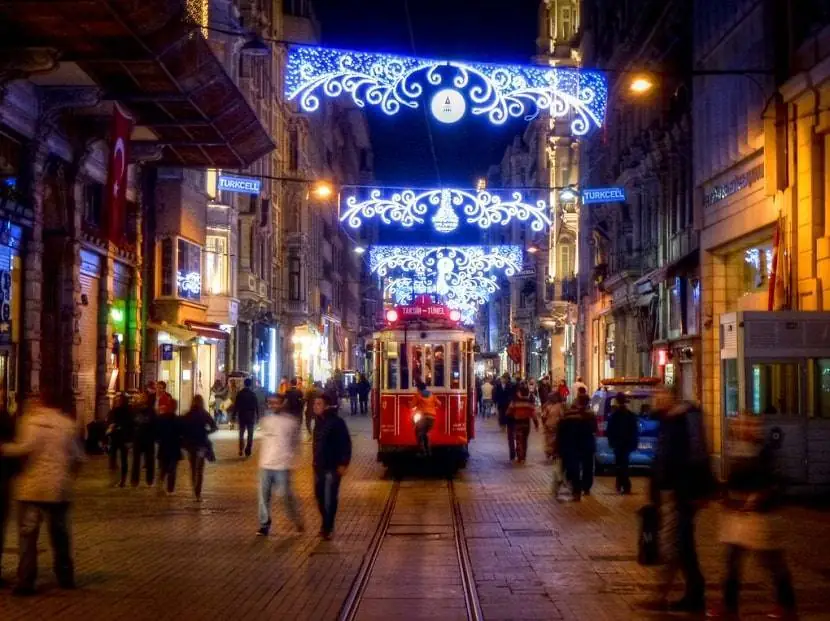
[0,407,83,502]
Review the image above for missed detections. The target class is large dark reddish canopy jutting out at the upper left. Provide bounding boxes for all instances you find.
[0,0,275,168]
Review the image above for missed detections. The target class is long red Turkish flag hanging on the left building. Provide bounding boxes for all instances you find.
[104,103,133,244]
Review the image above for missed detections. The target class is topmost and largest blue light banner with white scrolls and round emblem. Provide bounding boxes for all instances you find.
[285,46,608,136]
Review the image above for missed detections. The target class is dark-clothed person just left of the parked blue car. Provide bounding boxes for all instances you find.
[556,395,596,502]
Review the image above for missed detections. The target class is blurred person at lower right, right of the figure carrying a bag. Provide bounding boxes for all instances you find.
[707,414,796,619]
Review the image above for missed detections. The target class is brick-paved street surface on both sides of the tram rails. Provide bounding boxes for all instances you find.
[0,419,830,621]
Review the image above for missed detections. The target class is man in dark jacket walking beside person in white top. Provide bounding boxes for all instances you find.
[312,395,352,540]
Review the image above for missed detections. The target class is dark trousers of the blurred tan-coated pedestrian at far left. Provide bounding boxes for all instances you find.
[17,501,75,588]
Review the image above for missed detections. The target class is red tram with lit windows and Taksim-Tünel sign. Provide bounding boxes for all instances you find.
[372,301,475,467]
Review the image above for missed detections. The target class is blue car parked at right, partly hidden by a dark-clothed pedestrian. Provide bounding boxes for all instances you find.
[591,377,660,472]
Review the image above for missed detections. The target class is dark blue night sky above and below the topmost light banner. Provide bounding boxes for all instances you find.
[314,0,538,187]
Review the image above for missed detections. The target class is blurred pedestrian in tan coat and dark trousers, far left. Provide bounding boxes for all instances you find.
[0,402,83,595]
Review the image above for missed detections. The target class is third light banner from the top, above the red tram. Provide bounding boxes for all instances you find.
[369,246,522,278]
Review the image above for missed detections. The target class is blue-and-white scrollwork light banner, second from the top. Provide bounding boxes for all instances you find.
[340,188,551,233]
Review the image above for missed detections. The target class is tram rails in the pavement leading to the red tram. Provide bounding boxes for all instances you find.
[337,480,484,621]
